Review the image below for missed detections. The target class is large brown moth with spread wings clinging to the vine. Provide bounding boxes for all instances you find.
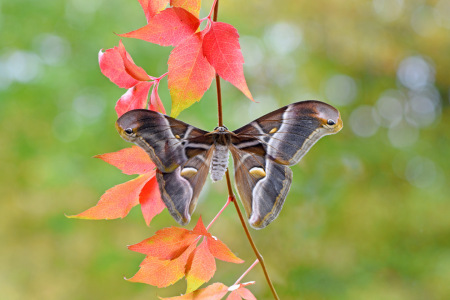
[116,100,343,229]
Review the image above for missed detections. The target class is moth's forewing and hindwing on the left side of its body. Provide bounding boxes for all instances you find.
[116,109,213,225]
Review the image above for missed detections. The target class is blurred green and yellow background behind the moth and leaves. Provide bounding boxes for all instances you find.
[0,0,450,299]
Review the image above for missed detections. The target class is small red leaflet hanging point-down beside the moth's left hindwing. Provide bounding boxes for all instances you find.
[139,177,166,226]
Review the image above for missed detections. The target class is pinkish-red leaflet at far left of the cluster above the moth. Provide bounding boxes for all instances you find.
[98,47,139,89]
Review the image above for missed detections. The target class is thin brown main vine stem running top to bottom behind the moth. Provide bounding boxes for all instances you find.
[213,0,280,300]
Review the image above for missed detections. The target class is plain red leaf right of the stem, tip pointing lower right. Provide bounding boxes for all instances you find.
[203,22,253,100]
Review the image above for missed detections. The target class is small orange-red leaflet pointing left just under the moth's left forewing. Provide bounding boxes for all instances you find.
[94,146,155,175]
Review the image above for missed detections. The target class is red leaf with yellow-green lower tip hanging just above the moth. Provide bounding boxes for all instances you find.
[168,32,215,117]
